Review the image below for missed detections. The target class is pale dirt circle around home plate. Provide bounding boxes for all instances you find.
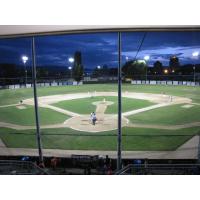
[64,114,128,132]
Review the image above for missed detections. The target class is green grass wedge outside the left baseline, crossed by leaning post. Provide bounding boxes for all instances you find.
[0,106,69,126]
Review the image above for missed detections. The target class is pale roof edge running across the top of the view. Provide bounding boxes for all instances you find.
[0,25,200,37]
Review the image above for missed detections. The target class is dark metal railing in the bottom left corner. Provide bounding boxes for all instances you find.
[0,160,47,175]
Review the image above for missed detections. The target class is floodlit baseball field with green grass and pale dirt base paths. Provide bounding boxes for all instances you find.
[0,84,200,151]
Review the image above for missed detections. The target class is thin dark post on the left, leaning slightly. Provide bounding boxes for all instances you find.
[32,37,43,163]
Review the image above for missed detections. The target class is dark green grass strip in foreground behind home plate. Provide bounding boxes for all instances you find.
[0,128,199,151]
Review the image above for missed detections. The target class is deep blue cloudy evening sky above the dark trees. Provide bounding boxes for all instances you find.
[0,32,200,68]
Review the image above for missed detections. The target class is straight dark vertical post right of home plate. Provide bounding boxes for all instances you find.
[117,32,122,170]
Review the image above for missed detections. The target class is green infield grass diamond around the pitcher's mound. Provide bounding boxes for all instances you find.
[53,96,153,114]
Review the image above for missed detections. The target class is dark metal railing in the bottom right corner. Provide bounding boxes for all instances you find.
[115,164,200,175]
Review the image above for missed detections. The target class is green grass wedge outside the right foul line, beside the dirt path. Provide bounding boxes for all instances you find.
[128,104,200,125]
